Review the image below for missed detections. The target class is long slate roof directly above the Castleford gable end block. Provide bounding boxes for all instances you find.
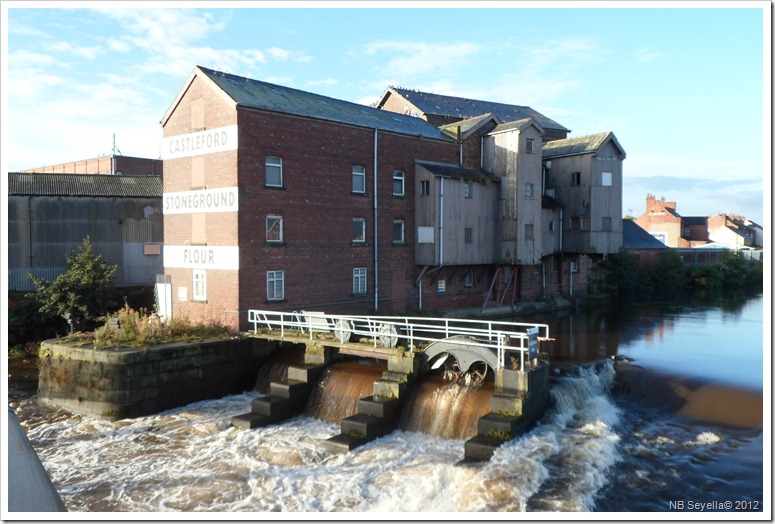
[198,66,450,141]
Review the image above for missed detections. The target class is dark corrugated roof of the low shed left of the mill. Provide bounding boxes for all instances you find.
[8,173,163,198]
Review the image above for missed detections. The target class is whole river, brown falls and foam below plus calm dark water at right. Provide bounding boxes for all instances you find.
[11,297,771,519]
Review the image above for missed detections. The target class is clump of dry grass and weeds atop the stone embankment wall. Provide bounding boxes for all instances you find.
[83,304,230,349]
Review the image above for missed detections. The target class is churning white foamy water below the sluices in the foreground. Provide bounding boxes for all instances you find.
[18,360,616,512]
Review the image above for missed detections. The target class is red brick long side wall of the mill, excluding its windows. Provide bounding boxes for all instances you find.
[233,110,456,324]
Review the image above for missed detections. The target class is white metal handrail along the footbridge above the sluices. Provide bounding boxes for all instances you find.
[248,309,549,369]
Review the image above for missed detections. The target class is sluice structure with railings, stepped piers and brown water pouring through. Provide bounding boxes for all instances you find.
[231,310,550,461]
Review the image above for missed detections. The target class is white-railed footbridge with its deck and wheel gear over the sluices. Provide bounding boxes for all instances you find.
[248,309,549,372]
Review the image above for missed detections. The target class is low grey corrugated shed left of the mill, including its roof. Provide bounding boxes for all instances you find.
[8,172,164,291]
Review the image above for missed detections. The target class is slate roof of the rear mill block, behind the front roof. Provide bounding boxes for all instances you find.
[382,86,570,132]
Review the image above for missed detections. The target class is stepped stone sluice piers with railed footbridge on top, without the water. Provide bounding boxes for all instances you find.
[231,310,551,461]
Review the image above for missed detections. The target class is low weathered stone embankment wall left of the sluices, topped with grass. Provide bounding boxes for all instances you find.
[38,338,277,420]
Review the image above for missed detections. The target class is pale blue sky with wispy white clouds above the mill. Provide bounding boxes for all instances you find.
[0,1,771,225]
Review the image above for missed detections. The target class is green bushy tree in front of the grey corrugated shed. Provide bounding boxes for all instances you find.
[28,237,118,330]
